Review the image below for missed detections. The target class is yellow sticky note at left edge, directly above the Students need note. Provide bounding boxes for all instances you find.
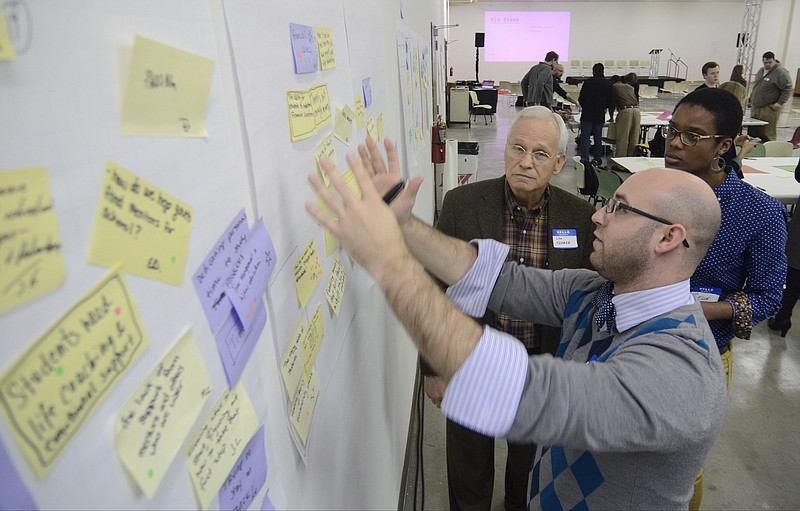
[0,168,64,311]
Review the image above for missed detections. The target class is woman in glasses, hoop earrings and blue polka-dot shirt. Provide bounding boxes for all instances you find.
[663,88,788,510]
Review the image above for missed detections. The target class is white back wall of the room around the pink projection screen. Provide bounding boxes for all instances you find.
[450,0,800,85]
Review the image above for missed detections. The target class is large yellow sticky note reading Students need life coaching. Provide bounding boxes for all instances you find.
[0,268,149,478]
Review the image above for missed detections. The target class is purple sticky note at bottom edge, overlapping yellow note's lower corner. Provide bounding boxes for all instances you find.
[219,426,267,510]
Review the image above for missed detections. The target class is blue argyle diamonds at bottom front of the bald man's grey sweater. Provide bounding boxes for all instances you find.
[529,445,604,511]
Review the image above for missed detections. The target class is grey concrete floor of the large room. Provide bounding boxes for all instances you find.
[400,95,800,510]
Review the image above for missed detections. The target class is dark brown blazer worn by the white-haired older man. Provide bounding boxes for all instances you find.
[420,176,595,376]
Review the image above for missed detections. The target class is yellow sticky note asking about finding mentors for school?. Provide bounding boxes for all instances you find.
[89,161,194,286]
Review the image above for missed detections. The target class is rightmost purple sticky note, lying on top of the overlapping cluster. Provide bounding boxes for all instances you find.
[225,219,275,329]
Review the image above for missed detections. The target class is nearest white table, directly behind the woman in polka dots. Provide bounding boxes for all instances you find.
[611,156,800,204]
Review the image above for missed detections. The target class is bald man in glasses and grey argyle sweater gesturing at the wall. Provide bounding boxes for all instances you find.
[307,127,725,509]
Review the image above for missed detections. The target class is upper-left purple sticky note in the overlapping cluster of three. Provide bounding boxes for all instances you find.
[192,209,249,333]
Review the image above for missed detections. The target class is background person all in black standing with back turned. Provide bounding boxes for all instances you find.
[578,62,614,167]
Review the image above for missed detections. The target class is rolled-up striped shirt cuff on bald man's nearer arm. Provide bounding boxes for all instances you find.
[442,327,528,437]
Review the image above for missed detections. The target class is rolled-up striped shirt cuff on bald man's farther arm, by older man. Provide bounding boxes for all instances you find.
[447,240,509,318]
